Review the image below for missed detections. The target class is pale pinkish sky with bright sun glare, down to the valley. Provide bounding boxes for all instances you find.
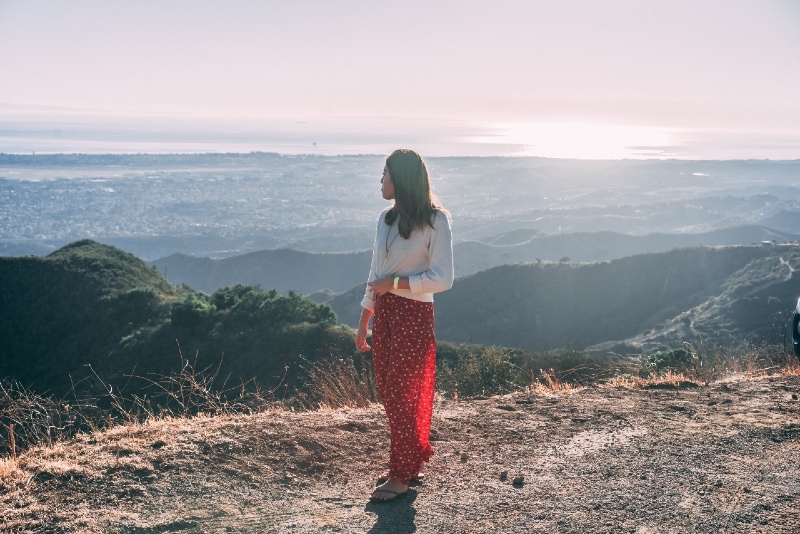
[0,0,800,159]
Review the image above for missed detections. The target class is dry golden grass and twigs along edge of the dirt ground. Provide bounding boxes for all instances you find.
[0,345,800,464]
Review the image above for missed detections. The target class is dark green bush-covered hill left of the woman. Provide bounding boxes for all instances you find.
[0,241,353,396]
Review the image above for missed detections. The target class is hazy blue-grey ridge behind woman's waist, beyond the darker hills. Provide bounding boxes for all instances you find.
[153,225,800,295]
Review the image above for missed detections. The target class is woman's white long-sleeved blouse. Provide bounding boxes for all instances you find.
[361,207,454,310]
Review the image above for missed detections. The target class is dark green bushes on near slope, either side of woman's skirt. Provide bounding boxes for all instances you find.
[0,241,624,418]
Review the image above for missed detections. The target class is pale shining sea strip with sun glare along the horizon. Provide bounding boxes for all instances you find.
[0,104,800,160]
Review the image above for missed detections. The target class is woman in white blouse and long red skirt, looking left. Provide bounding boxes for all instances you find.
[356,149,453,502]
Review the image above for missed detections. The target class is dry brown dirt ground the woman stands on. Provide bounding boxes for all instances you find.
[0,375,800,534]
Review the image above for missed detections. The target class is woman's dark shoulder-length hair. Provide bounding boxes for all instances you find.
[384,148,446,239]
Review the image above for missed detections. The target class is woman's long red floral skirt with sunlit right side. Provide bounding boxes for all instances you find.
[372,293,436,484]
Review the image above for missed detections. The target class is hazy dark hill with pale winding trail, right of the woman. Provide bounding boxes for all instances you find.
[321,245,800,353]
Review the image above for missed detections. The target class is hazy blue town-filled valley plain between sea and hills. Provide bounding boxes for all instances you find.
[0,153,800,261]
